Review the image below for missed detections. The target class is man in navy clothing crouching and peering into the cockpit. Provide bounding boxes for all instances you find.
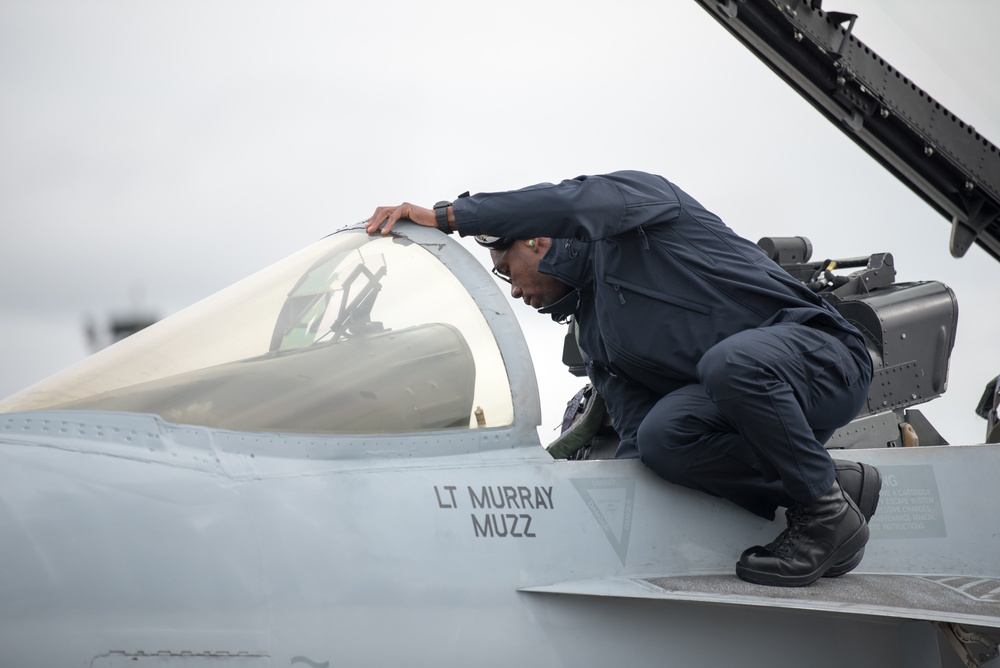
[366,171,881,586]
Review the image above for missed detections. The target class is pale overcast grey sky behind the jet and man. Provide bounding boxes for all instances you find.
[0,0,1000,442]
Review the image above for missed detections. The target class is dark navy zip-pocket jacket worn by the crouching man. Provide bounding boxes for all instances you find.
[453,171,871,456]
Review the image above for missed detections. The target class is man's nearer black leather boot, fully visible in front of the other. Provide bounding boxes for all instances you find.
[736,481,868,587]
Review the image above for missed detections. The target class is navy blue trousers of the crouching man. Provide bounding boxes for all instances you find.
[636,323,871,519]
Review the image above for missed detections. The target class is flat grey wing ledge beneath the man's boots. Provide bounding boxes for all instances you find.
[520,573,1000,628]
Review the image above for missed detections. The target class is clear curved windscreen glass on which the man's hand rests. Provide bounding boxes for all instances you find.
[0,229,514,434]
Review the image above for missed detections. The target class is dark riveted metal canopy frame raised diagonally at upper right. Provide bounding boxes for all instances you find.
[696,0,1000,260]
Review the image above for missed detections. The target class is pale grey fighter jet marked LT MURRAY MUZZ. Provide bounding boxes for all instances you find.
[0,2,1000,668]
